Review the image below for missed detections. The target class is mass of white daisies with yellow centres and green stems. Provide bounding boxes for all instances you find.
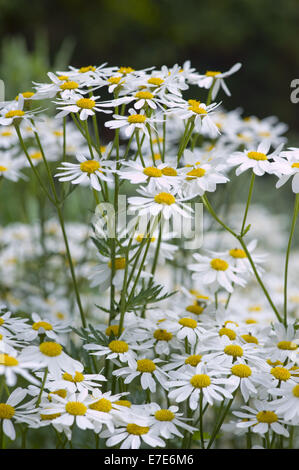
[0,61,299,449]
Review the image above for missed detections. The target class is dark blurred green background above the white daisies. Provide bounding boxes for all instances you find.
[0,0,299,228]
